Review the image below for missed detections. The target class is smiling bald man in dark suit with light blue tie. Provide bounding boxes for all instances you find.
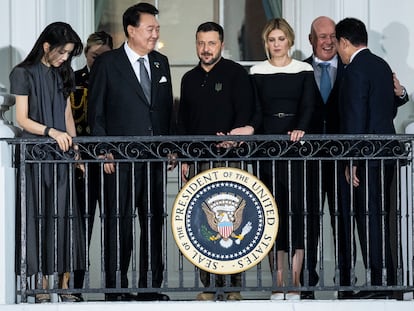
[301,16,344,299]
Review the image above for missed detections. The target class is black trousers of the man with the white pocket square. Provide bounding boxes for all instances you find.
[101,163,165,288]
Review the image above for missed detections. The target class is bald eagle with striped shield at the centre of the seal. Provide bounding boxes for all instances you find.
[201,193,252,248]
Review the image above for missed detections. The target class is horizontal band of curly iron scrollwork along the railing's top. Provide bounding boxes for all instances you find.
[13,136,413,162]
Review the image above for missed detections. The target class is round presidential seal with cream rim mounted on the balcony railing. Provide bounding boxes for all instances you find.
[171,167,279,274]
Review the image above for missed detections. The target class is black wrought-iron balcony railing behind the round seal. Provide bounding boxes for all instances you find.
[8,135,414,302]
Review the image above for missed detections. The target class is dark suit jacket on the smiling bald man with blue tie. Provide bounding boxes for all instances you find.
[304,56,345,134]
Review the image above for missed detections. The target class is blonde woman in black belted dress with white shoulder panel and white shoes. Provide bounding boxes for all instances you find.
[250,18,316,300]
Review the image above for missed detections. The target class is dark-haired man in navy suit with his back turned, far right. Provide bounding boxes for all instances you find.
[335,18,398,298]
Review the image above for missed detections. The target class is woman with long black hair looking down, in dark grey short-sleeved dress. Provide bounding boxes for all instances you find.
[10,22,85,302]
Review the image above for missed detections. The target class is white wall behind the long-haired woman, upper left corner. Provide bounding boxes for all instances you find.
[0,0,94,89]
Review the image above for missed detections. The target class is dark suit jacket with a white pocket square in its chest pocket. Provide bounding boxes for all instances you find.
[89,45,173,136]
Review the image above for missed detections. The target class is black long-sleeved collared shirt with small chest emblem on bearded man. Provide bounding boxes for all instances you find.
[178,58,254,135]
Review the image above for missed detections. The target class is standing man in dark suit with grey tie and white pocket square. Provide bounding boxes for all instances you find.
[89,3,173,300]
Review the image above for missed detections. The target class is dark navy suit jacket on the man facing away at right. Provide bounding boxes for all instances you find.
[339,49,397,134]
